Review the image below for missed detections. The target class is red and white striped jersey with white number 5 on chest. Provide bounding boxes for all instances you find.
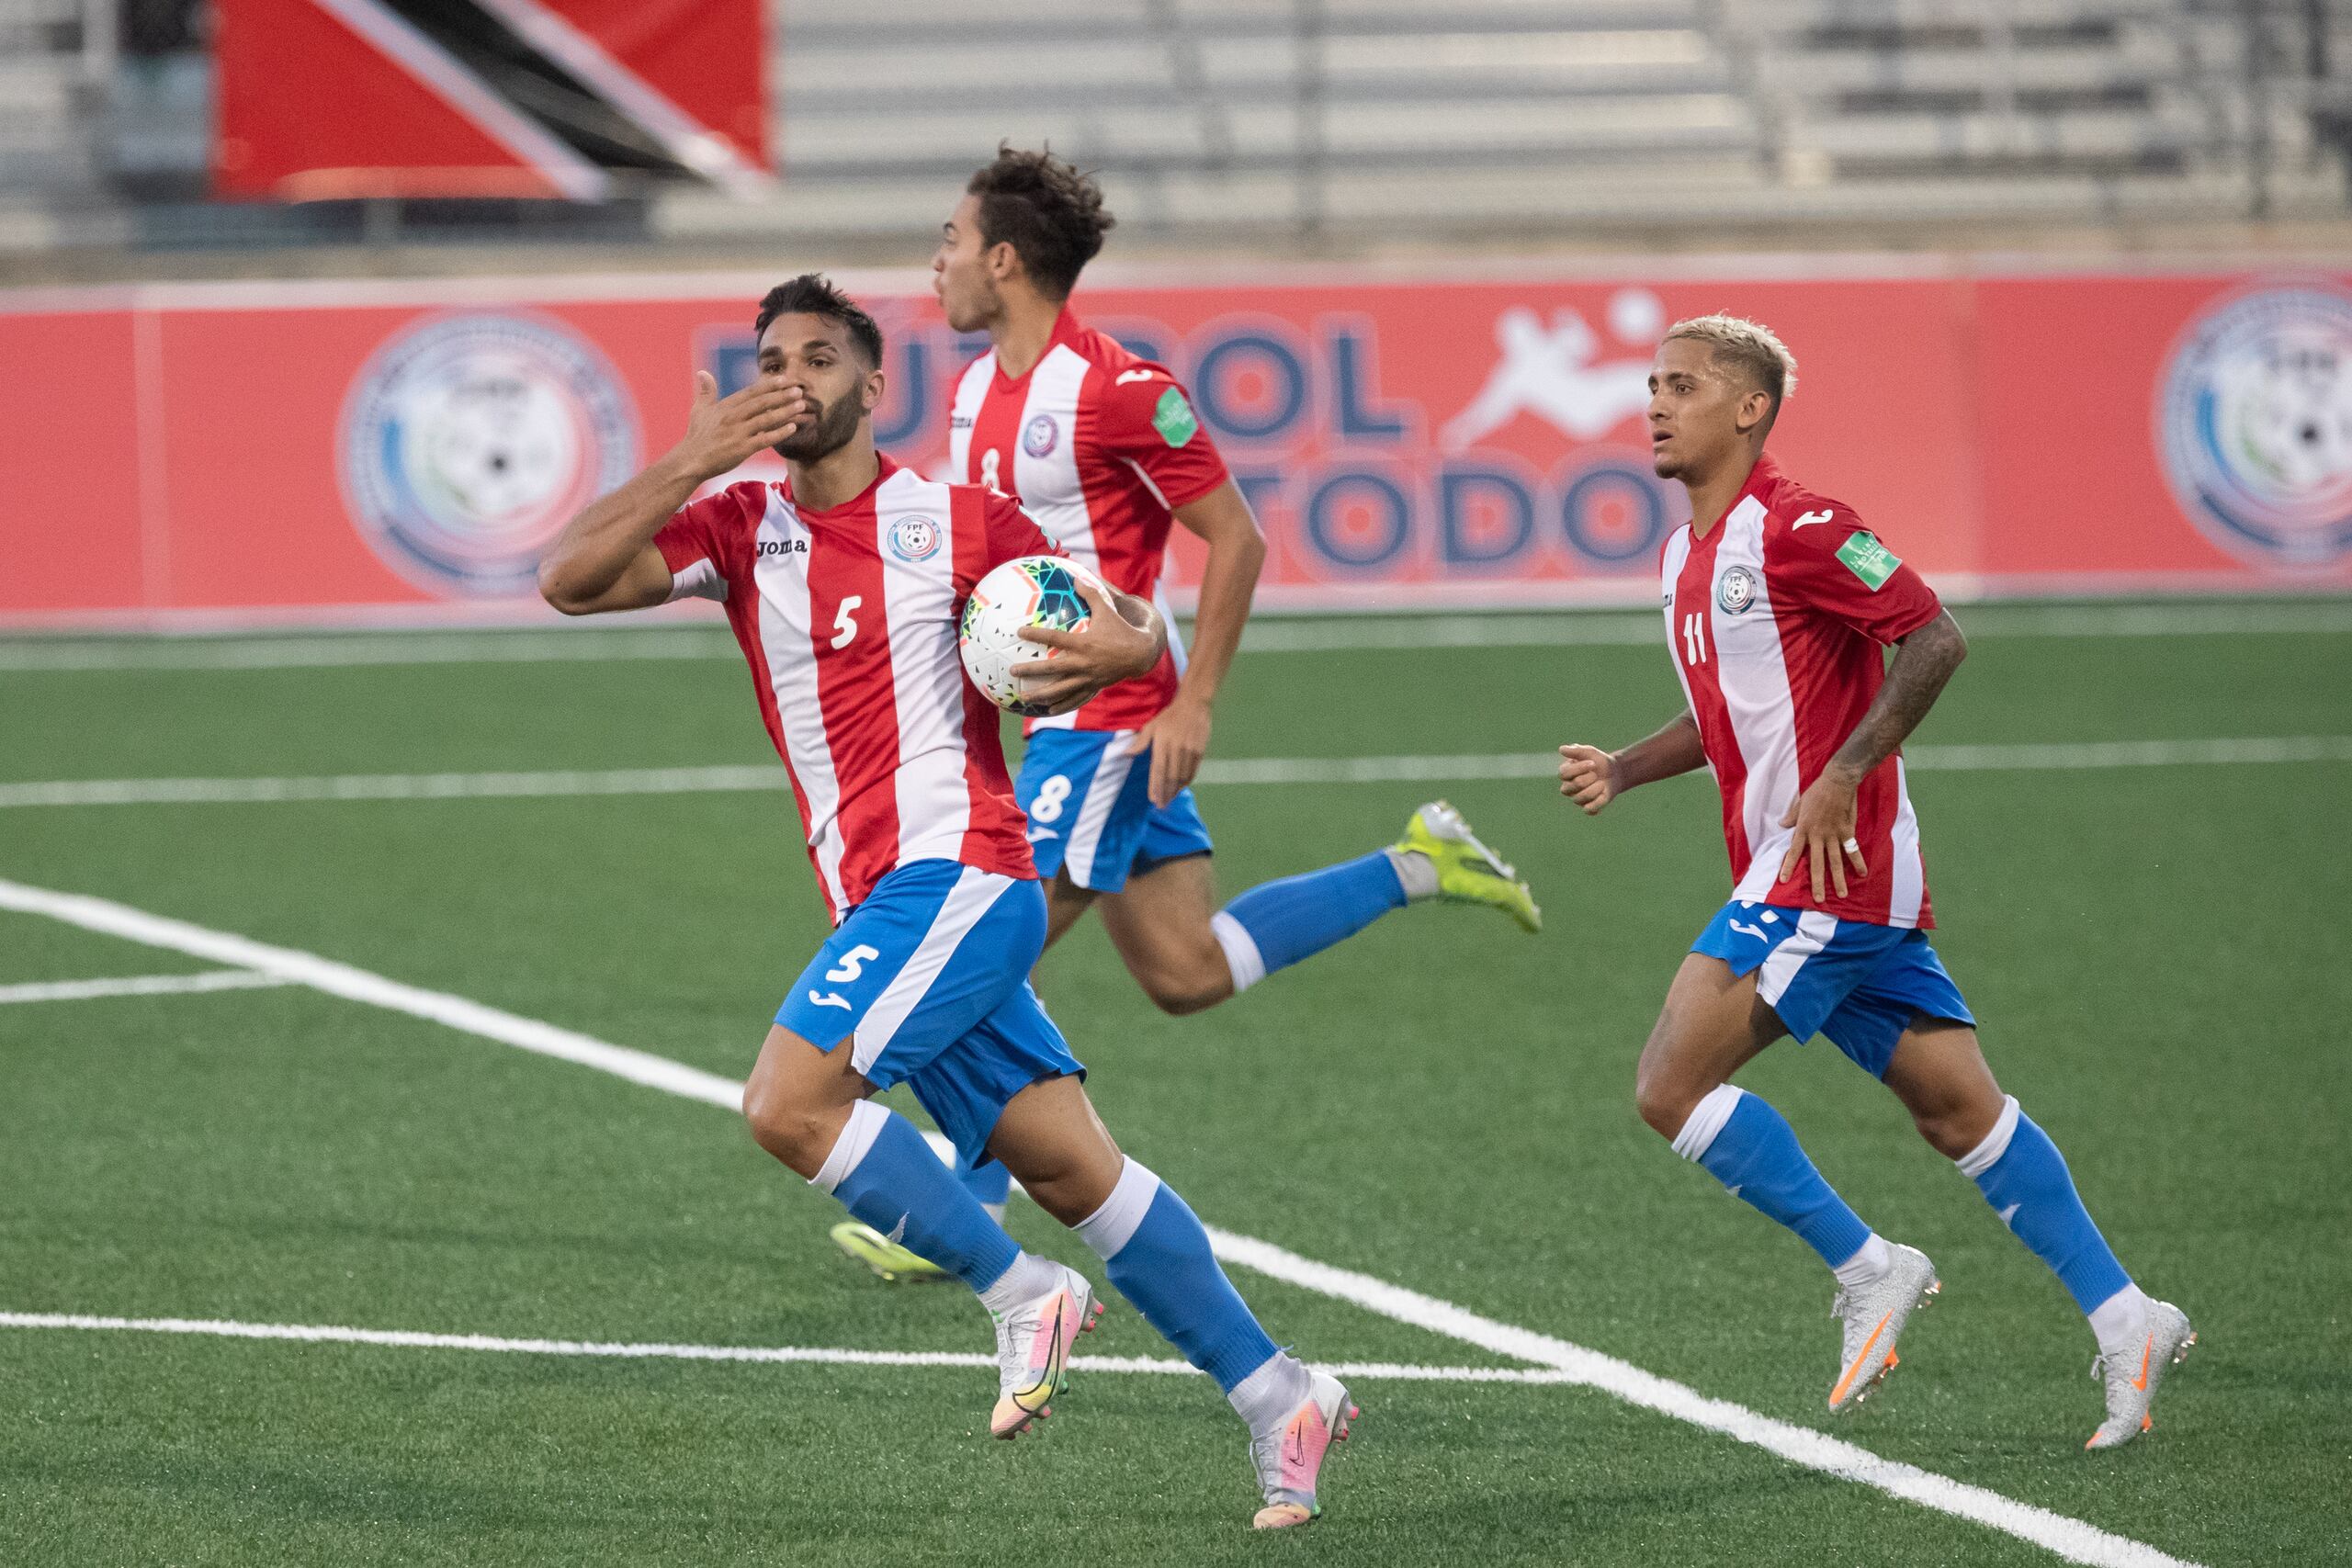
[654,458,1054,921]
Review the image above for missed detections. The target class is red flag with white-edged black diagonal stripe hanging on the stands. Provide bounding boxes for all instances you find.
[211,0,772,202]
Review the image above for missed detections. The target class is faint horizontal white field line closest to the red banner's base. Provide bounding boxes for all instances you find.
[0,600,2352,672]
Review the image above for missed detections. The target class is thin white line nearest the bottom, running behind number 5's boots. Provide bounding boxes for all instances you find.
[0,1312,1569,1382]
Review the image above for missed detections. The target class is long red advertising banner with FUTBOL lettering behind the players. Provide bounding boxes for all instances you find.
[0,270,2352,626]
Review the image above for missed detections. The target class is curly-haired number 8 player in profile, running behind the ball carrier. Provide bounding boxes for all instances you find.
[835,148,1543,1279]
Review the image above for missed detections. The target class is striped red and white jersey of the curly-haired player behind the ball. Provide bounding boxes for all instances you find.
[948,308,1226,728]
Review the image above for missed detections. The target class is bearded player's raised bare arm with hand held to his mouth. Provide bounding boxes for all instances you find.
[538,371,807,616]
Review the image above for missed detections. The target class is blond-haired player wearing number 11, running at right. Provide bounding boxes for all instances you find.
[1559,315,2197,1448]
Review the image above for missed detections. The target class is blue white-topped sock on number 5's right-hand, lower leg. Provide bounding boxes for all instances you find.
[1077,1159,1280,1392]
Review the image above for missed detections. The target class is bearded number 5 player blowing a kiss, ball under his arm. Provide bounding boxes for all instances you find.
[538,275,1355,1528]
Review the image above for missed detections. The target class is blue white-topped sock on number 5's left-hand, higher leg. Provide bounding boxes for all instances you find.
[809,1100,1021,1291]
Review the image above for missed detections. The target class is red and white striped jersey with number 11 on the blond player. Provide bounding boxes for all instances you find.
[1663,456,1943,926]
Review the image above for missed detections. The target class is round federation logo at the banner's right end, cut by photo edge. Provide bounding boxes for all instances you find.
[2157,285,2352,567]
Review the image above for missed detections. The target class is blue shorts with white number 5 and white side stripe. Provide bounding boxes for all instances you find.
[776,861,1087,1166]
